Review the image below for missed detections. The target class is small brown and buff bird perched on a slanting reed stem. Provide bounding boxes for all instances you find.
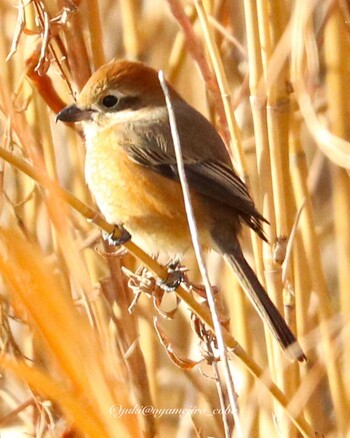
[57,59,306,361]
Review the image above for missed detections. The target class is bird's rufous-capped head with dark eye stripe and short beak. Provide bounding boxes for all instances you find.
[56,60,182,127]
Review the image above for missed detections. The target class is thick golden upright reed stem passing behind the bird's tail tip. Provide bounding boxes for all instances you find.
[258,1,299,437]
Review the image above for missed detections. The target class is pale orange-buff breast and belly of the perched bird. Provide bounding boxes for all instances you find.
[85,135,210,256]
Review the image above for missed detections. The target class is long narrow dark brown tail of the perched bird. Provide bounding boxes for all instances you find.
[216,239,306,361]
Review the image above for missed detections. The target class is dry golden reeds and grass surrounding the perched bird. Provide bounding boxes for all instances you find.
[0,0,350,437]
